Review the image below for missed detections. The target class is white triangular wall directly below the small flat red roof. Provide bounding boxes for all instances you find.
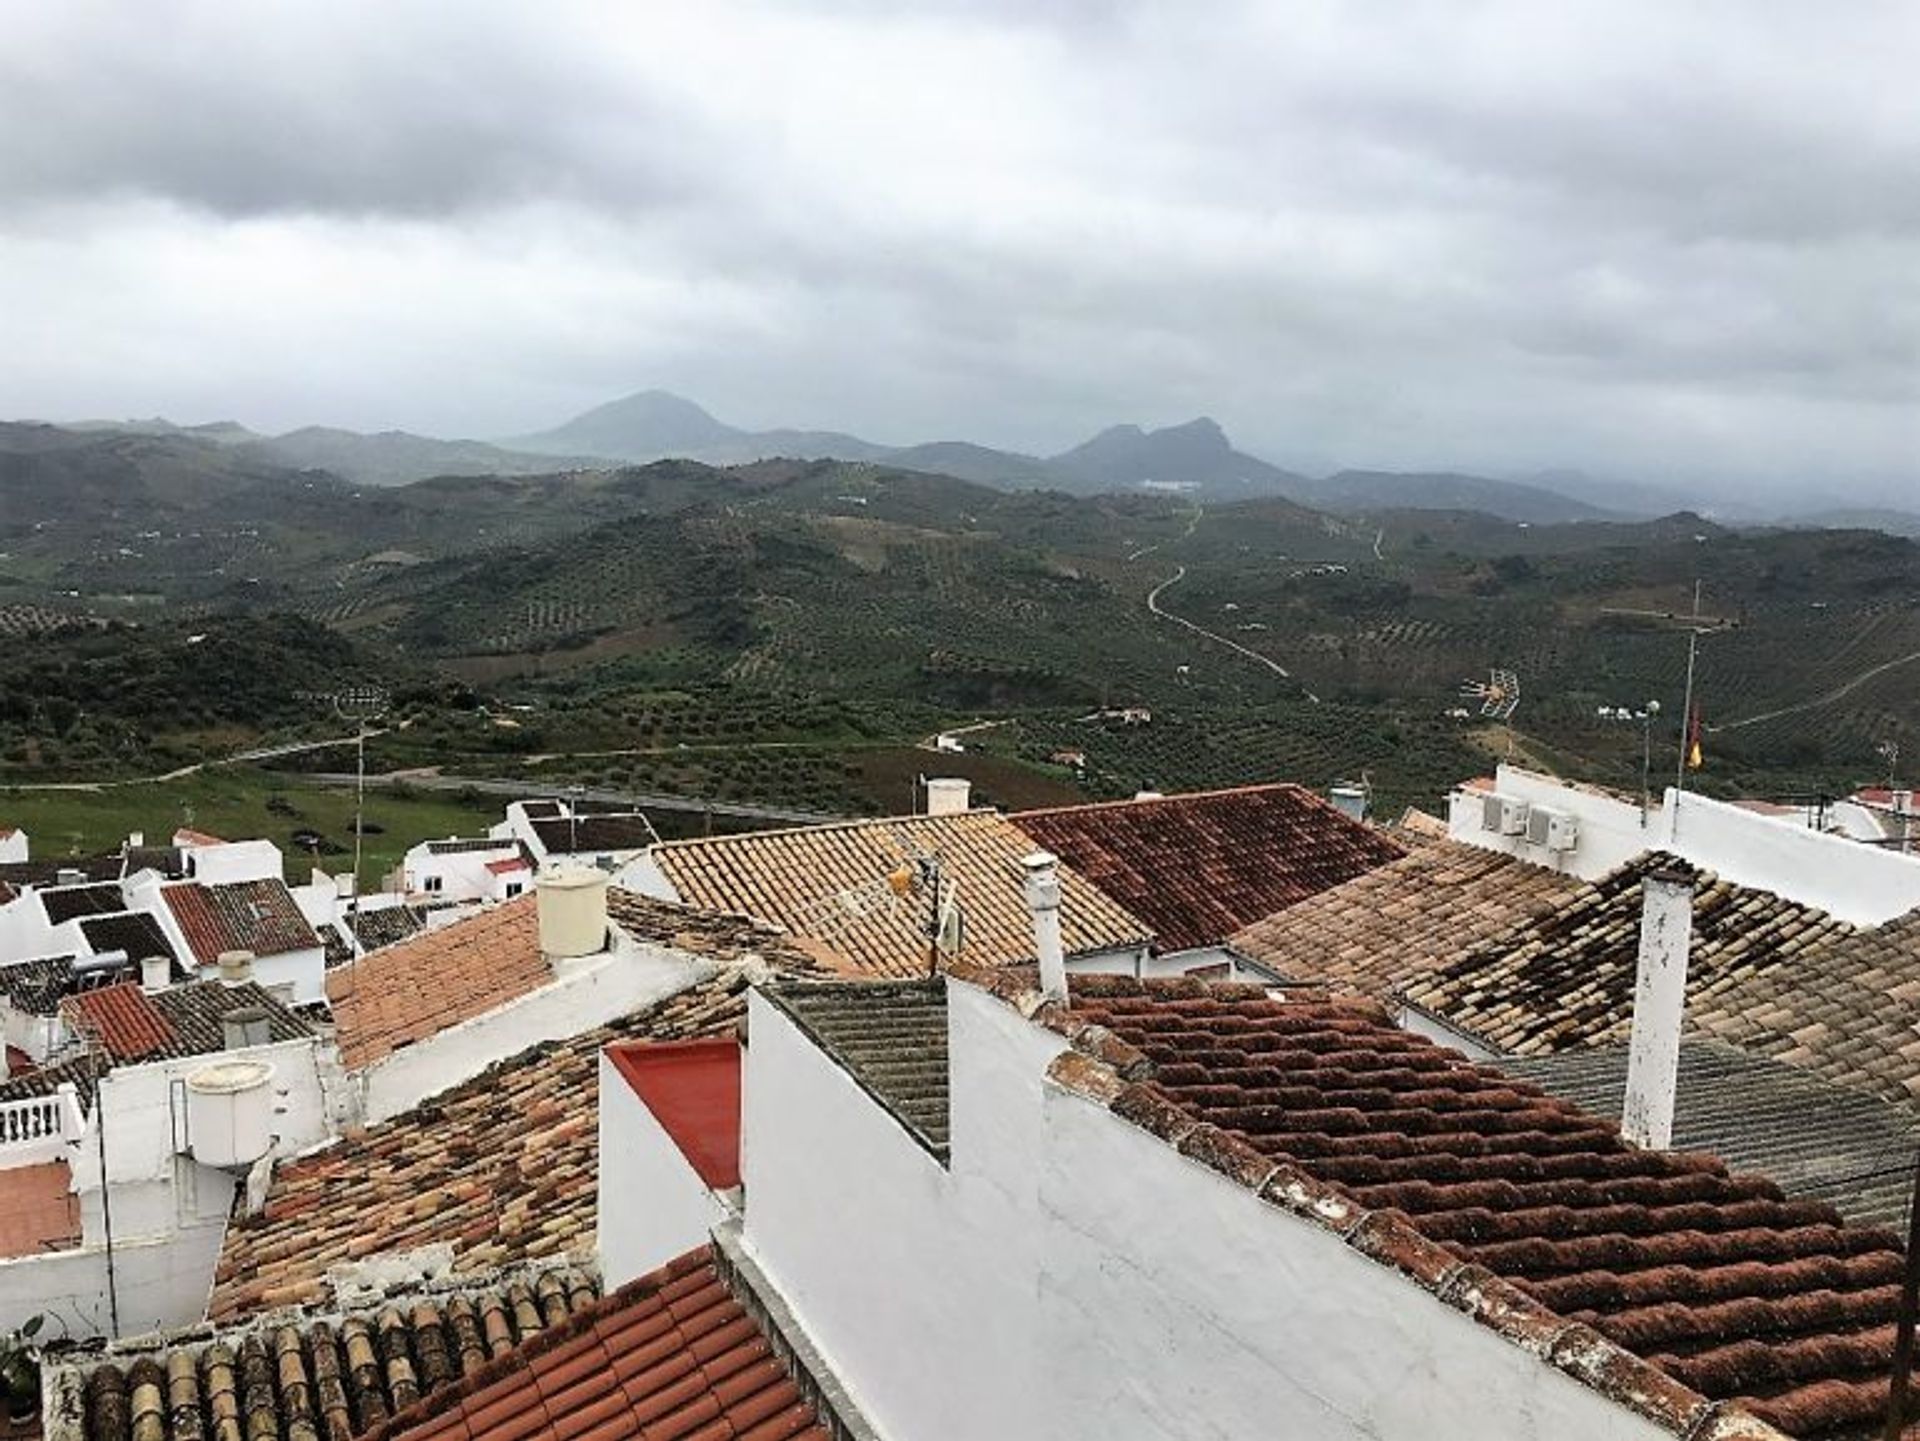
[595,1051,732,1291]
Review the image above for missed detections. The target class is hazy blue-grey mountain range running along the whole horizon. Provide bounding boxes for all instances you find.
[33,390,1920,535]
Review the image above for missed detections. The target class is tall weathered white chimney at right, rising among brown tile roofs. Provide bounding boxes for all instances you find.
[1620,867,1693,1151]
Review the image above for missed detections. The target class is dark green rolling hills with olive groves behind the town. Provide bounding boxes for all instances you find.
[0,426,1920,817]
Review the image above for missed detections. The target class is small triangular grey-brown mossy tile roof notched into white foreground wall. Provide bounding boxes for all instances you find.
[764,980,950,1159]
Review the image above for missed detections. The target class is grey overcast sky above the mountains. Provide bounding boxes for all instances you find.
[0,0,1920,505]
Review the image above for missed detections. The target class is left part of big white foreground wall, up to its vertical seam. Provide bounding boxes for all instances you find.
[741,986,1060,1439]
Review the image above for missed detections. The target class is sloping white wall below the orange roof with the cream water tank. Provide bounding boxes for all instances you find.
[355,942,716,1124]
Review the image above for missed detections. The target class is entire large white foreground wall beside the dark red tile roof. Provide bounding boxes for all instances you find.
[743,982,1667,1441]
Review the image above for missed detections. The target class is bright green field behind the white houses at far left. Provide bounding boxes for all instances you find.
[0,768,505,888]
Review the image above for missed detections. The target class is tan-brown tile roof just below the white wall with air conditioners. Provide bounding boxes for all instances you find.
[1233,840,1580,996]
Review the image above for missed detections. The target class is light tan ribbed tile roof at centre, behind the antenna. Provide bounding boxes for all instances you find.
[653,810,1152,977]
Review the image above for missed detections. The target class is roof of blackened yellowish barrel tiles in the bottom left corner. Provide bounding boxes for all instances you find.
[72,1266,597,1441]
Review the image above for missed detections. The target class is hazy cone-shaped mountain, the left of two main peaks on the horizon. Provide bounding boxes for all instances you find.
[507,390,887,464]
